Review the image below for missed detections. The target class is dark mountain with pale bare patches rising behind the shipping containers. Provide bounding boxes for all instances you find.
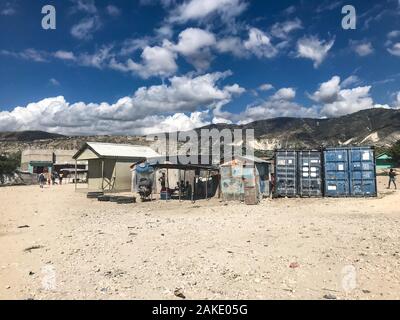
[198,109,400,150]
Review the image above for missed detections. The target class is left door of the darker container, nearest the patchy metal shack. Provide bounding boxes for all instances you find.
[275,150,297,197]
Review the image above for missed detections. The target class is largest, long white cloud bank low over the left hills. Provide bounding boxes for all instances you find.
[0,72,244,134]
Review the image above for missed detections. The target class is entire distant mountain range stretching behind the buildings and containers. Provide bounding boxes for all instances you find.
[0,109,400,153]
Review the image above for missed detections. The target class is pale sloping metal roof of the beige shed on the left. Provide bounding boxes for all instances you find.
[87,142,160,158]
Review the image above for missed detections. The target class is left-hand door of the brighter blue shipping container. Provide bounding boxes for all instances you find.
[324,148,350,197]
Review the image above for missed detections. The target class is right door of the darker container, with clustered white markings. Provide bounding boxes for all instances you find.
[298,150,322,197]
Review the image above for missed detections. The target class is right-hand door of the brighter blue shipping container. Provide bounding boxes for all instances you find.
[349,148,377,197]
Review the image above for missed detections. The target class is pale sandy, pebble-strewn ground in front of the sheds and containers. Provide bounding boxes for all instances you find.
[0,178,400,299]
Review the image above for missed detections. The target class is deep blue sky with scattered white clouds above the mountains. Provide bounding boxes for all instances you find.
[0,0,400,135]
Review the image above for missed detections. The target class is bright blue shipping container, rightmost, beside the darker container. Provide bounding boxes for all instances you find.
[324,147,377,197]
